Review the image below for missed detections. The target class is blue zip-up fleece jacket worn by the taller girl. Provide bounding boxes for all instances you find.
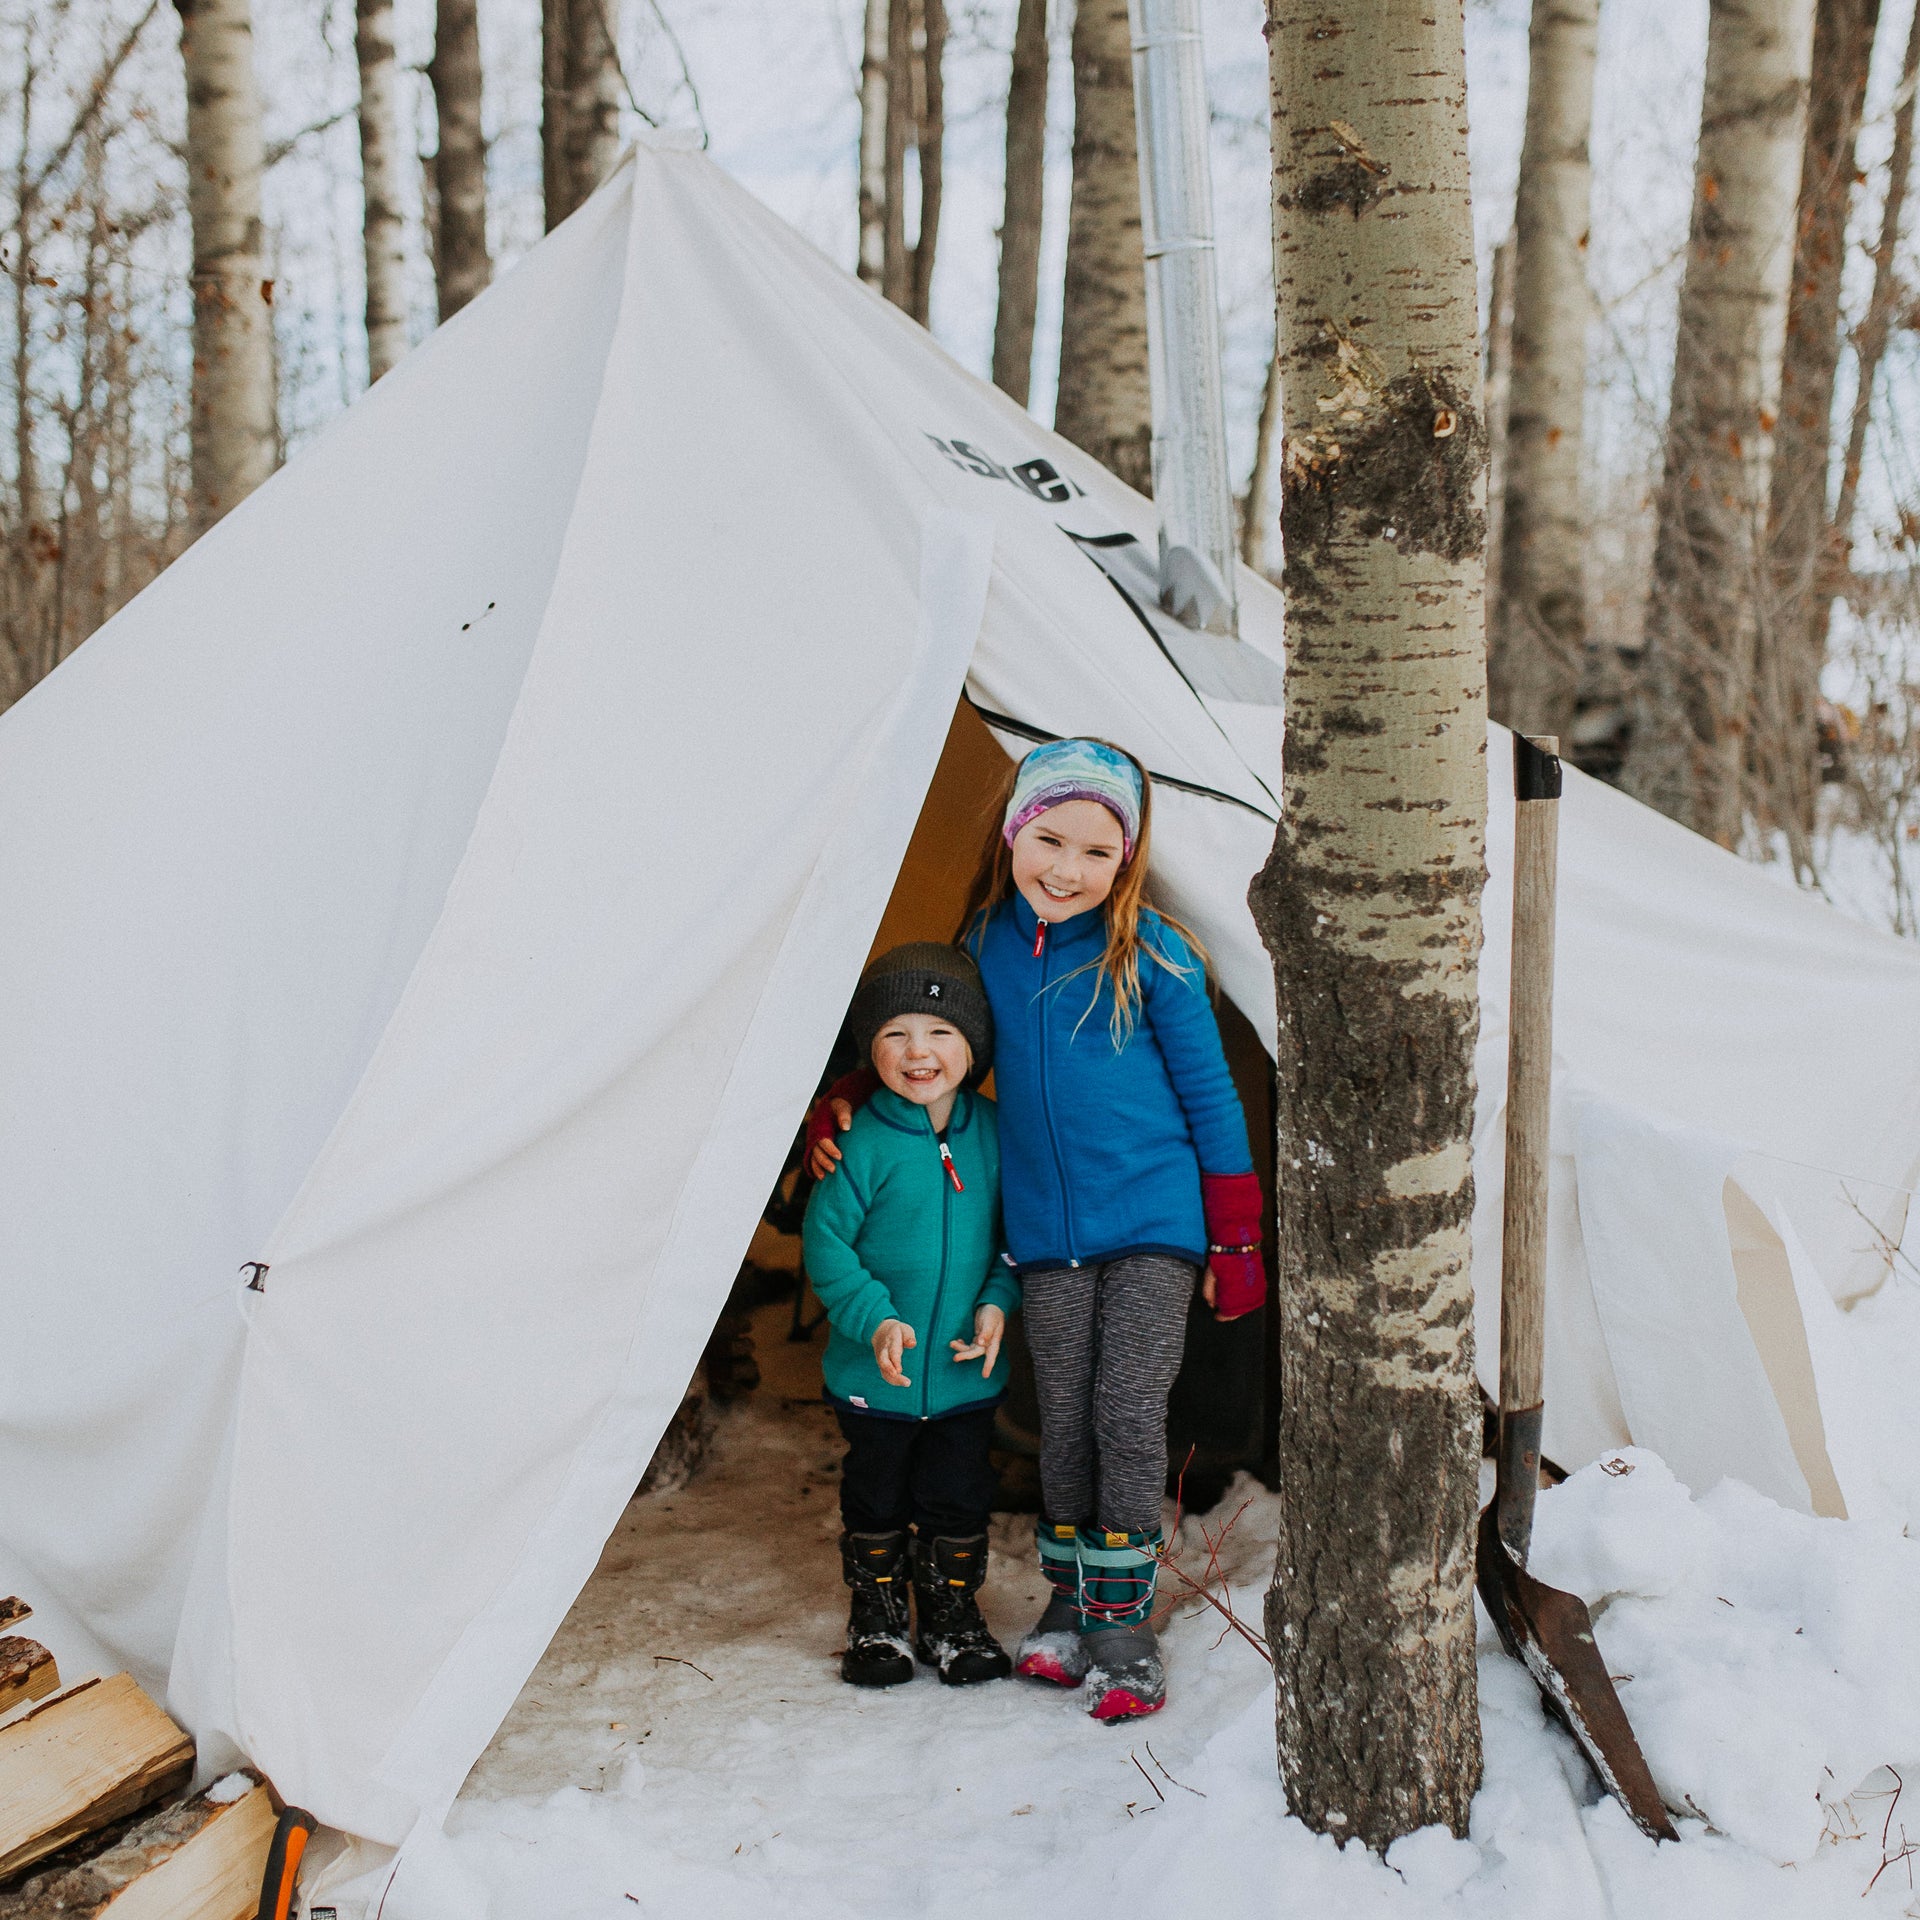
[966,893,1254,1271]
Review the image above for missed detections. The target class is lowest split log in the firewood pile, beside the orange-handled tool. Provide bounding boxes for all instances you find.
[0,1774,275,1920]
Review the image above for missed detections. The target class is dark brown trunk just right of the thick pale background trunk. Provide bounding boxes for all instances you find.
[1755,0,1880,877]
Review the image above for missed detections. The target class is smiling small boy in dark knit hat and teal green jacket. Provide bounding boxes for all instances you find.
[804,943,1020,1686]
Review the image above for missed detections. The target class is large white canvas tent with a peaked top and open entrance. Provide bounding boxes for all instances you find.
[11,144,1920,1843]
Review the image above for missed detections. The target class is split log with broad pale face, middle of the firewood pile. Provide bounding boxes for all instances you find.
[0,1674,194,1880]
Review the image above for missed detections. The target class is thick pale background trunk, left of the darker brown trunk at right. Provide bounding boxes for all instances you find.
[1622,0,1812,847]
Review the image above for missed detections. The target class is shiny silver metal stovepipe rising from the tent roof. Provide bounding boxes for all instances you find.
[1127,0,1238,634]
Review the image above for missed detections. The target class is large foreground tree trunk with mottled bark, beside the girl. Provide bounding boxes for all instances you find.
[1248,0,1486,1849]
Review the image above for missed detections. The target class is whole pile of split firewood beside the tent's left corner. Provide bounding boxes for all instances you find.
[0,1599,284,1920]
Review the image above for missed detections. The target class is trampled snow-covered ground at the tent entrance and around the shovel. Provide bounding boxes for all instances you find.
[299,1308,1920,1920]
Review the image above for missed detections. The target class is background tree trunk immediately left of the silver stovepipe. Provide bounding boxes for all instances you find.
[1054,0,1154,493]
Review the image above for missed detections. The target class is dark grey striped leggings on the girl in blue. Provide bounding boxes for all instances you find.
[1021,1254,1200,1534]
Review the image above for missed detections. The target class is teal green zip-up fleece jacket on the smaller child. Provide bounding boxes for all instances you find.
[803,1087,1020,1421]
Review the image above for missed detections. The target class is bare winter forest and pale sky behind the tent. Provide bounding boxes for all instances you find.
[11,0,1920,935]
